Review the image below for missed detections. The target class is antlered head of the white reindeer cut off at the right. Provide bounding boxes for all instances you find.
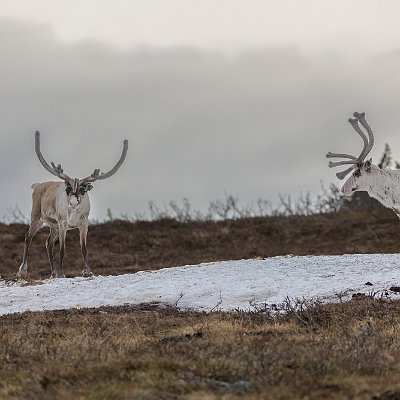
[326,112,379,195]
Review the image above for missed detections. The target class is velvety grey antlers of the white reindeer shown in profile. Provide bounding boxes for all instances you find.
[326,112,374,179]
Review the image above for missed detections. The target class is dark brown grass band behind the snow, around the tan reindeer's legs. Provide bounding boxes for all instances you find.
[0,209,400,279]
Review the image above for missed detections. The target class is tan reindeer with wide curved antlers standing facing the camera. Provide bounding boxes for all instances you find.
[17,131,128,278]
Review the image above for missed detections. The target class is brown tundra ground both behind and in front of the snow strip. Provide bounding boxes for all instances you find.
[0,210,400,400]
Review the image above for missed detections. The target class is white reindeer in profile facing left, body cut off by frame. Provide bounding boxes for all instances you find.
[326,112,400,218]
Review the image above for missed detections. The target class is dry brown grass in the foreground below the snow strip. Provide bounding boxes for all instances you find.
[0,298,400,400]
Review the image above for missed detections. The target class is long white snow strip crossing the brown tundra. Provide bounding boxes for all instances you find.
[0,254,400,315]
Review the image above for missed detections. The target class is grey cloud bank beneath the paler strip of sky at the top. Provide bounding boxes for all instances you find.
[0,20,400,218]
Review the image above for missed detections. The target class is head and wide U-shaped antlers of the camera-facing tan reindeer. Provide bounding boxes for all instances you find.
[35,131,128,208]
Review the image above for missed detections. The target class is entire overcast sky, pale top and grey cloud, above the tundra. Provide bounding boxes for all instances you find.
[0,0,400,218]
